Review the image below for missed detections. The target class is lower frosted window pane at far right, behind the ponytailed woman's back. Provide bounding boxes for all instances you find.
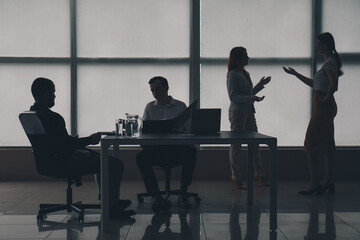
[335,62,360,146]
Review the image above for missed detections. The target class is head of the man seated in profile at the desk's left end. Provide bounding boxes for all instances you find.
[31,78,55,108]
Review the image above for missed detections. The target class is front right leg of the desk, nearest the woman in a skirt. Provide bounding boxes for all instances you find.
[269,142,277,231]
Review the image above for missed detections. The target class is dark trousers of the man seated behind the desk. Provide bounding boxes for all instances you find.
[136,146,196,198]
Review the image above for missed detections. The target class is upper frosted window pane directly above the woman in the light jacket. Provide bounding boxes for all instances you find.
[201,0,311,57]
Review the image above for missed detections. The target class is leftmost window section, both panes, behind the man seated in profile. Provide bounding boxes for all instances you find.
[0,0,71,146]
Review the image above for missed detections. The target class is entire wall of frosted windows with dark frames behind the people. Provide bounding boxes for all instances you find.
[0,0,360,146]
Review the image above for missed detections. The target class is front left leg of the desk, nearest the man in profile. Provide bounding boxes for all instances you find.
[100,142,110,232]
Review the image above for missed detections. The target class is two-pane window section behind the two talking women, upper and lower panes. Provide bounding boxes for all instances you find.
[201,0,312,146]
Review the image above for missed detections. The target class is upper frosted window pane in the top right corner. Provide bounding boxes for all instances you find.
[322,0,360,52]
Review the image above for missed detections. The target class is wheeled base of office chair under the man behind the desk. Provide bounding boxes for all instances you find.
[137,164,201,204]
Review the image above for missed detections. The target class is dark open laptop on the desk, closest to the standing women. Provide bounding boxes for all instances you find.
[190,108,221,134]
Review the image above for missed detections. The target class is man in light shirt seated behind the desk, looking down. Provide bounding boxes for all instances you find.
[136,76,196,211]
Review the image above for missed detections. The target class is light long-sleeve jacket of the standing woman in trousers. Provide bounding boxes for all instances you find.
[226,70,264,113]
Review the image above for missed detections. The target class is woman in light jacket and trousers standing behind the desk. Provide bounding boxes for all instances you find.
[226,47,271,189]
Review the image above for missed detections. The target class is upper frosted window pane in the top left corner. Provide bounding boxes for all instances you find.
[0,0,70,57]
